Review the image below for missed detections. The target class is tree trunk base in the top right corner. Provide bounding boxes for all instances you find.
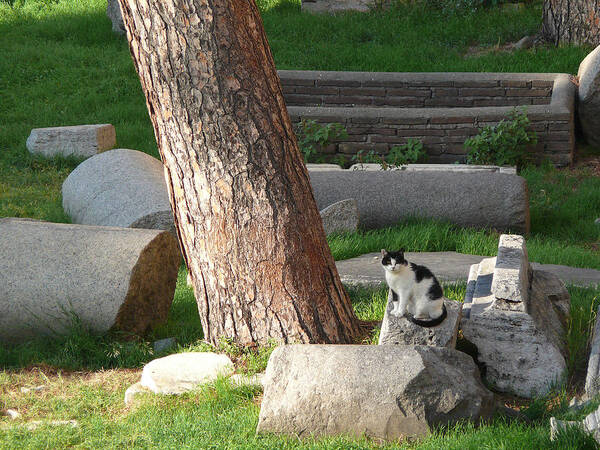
[542,0,600,47]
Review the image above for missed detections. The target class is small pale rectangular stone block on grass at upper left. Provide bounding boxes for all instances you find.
[26,123,117,158]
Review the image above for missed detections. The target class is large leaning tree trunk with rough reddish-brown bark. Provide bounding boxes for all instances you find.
[120,0,359,343]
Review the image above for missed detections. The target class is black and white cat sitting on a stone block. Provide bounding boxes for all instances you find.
[381,249,447,327]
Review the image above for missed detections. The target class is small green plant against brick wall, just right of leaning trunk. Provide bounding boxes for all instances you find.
[296,119,348,162]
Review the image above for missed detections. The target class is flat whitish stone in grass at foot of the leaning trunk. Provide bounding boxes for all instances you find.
[140,352,234,394]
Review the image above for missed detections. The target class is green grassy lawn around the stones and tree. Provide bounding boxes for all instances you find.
[0,0,600,449]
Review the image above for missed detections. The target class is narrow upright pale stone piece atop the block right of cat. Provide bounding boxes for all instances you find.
[491,234,531,310]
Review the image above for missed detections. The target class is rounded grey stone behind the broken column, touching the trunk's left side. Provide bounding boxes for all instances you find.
[62,148,175,233]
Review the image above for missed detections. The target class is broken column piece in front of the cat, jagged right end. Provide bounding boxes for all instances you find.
[257,345,494,440]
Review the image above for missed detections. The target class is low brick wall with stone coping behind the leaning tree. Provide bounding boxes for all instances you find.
[279,70,575,166]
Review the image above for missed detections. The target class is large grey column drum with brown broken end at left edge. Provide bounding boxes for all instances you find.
[0,218,181,342]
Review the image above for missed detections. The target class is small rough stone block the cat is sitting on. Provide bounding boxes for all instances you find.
[379,291,462,348]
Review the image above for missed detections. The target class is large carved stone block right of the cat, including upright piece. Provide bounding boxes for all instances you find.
[461,235,570,397]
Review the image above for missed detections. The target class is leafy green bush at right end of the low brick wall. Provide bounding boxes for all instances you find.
[465,108,537,167]
